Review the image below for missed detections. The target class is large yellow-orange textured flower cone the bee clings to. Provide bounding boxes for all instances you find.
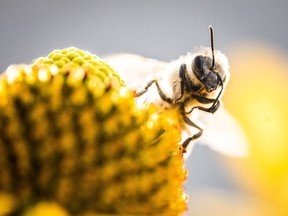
[0,48,187,216]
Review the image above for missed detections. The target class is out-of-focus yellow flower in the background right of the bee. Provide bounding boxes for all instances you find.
[224,43,288,215]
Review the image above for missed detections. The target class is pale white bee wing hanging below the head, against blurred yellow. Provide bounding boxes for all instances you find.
[199,104,249,157]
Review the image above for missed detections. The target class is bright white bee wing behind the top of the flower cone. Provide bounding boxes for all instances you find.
[104,53,168,90]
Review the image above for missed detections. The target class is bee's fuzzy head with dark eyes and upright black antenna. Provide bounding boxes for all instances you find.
[191,27,229,93]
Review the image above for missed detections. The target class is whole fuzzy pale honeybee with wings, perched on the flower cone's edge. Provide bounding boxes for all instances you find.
[105,26,247,156]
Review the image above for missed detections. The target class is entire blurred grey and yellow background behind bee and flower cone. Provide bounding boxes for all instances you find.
[0,0,288,216]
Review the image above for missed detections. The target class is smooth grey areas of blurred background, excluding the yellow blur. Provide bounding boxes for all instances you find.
[0,0,288,215]
